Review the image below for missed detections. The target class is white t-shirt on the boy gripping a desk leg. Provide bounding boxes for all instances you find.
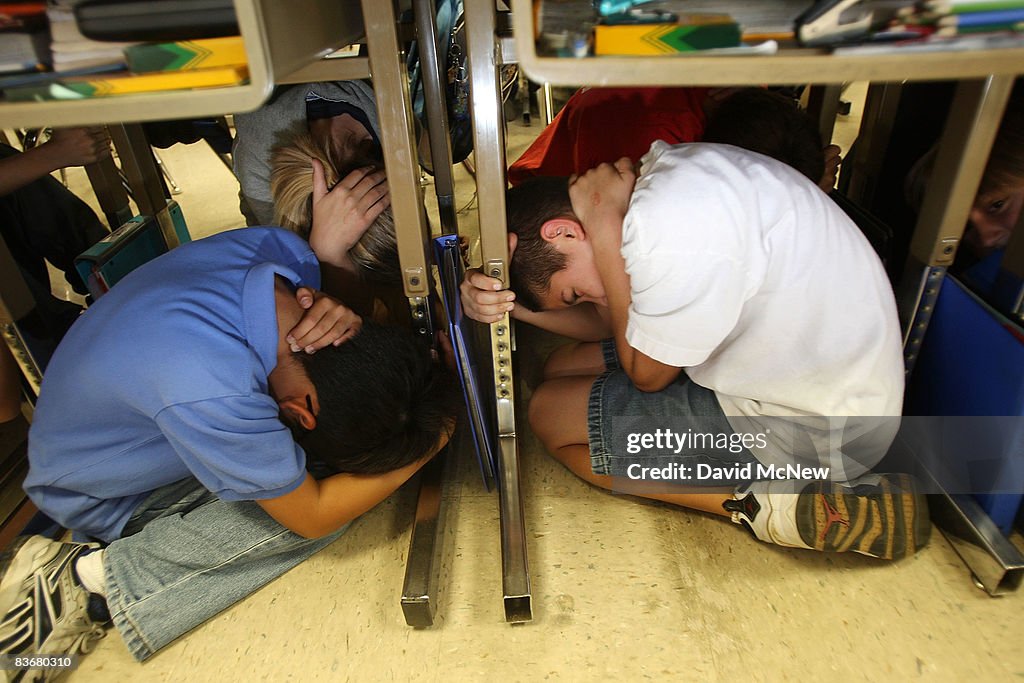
[622,141,903,473]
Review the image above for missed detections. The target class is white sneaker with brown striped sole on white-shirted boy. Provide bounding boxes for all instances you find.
[723,474,932,560]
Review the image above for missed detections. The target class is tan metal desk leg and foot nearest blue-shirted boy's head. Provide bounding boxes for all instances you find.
[362,0,444,627]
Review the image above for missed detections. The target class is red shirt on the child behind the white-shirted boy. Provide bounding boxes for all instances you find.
[508,88,708,185]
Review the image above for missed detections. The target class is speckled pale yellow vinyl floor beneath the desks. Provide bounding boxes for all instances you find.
[58,88,1024,683]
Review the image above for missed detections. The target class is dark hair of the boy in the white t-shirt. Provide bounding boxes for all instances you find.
[505,177,573,310]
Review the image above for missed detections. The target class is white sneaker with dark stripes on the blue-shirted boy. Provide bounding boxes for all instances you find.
[0,536,105,680]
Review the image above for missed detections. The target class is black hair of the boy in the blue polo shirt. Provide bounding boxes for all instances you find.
[295,319,462,474]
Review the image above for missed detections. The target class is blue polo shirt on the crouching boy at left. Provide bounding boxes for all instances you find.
[25,227,319,541]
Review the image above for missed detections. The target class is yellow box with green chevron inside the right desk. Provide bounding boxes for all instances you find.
[594,14,740,55]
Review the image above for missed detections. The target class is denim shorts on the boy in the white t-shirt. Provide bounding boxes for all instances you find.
[587,340,758,486]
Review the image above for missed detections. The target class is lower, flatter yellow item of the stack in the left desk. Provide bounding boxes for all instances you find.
[3,67,249,102]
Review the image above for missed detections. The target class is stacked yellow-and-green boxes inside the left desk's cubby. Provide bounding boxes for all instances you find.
[0,36,249,101]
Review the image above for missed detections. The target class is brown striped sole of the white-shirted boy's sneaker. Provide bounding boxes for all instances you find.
[797,474,932,560]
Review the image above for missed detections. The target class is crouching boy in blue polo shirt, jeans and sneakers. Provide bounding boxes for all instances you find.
[0,227,459,660]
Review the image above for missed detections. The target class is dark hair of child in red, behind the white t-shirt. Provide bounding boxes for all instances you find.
[701,88,825,189]
